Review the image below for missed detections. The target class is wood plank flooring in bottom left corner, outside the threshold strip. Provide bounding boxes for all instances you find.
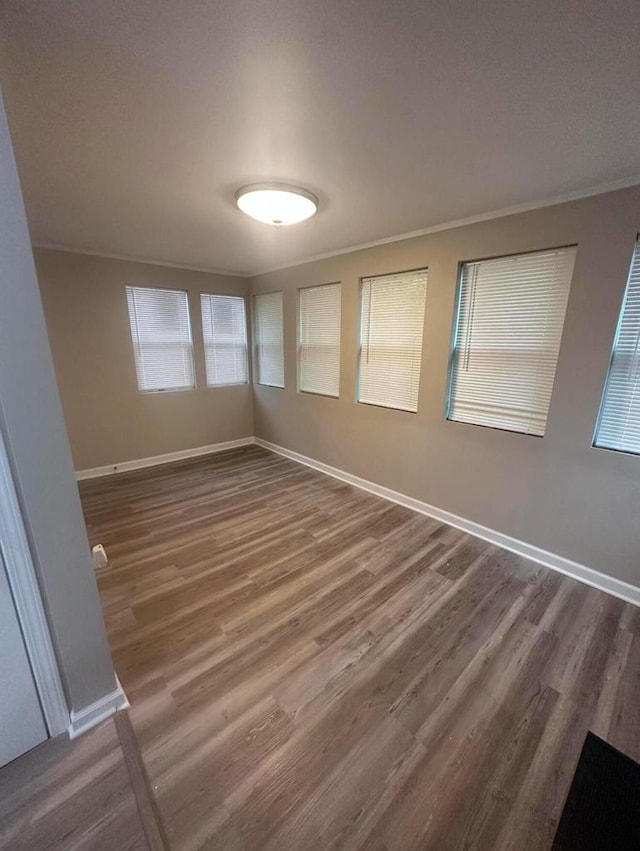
[0,713,168,851]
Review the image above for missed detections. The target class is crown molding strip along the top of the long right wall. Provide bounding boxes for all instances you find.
[247,174,640,278]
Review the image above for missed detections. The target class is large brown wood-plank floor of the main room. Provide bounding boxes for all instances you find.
[81,447,640,851]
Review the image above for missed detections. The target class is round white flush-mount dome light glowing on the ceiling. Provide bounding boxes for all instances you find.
[236,183,318,227]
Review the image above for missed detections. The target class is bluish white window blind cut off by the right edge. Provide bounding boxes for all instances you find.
[595,236,640,454]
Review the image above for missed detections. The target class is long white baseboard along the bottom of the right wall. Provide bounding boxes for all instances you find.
[255,437,640,606]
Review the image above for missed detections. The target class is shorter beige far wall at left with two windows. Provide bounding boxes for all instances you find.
[35,249,253,470]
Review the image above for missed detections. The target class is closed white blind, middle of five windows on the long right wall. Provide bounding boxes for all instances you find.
[358,269,427,411]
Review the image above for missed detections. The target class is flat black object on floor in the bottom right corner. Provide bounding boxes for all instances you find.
[552,733,640,851]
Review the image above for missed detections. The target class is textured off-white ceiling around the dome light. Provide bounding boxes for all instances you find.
[0,0,640,273]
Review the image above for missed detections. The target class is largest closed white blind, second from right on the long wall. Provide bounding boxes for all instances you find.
[448,248,576,437]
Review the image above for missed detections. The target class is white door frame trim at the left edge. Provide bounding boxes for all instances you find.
[0,430,70,737]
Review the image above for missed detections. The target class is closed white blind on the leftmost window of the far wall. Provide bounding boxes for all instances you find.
[127,287,195,391]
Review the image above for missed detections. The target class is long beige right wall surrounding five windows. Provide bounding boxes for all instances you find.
[252,187,640,585]
